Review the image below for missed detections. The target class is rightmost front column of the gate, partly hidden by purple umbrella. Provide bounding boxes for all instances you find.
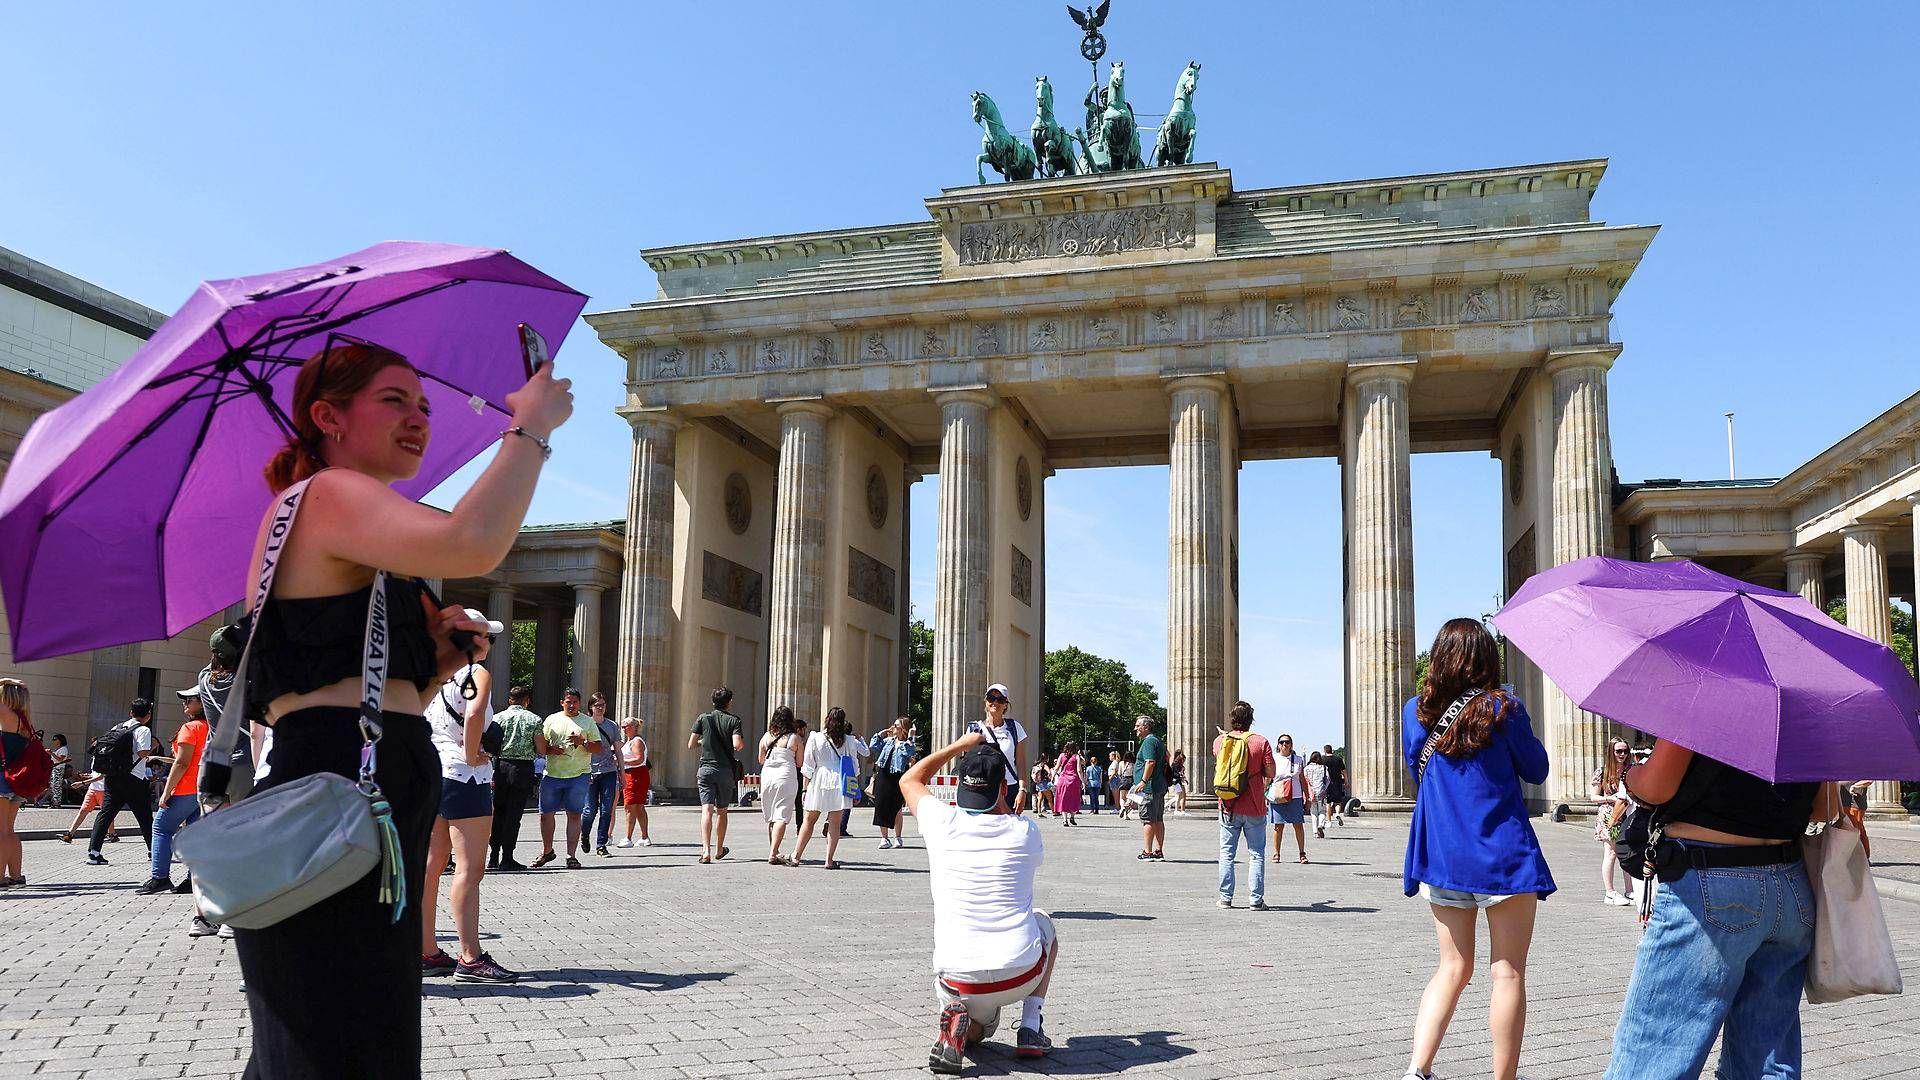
[1544,344,1620,809]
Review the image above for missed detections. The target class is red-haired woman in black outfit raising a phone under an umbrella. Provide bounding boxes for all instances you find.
[234,342,572,1080]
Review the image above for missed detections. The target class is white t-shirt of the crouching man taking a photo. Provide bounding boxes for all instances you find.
[914,794,1046,972]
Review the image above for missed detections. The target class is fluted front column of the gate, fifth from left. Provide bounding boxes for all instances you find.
[1342,363,1415,811]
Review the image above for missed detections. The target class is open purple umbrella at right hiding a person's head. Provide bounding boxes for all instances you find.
[1494,555,1920,782]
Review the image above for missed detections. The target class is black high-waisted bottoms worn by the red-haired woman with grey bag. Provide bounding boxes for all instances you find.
[234,705,440,1080]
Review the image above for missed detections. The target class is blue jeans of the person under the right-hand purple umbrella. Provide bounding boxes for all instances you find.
[1607,840,1814,1080]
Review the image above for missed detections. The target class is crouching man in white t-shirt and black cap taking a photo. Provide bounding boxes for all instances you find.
[900,732,1060,1072]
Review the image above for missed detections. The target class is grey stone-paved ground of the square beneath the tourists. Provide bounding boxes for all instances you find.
[0,807,1920,1080]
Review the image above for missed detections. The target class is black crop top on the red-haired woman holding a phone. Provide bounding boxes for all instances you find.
[248,575,440,719]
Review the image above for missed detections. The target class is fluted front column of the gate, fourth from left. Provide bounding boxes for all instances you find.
[1167,375,1227,784]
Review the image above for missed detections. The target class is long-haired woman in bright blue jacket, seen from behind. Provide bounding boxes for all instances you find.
[1400,619,1555,1080]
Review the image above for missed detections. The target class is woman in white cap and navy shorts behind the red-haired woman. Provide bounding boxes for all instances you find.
[420,607,520,982]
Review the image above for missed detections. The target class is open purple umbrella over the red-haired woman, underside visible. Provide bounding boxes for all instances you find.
[0,240,586,661]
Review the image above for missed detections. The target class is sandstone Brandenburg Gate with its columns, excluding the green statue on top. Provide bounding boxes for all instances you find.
[588,160,1655,809]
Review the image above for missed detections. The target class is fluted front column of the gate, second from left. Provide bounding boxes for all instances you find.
[766,402,833,728]
